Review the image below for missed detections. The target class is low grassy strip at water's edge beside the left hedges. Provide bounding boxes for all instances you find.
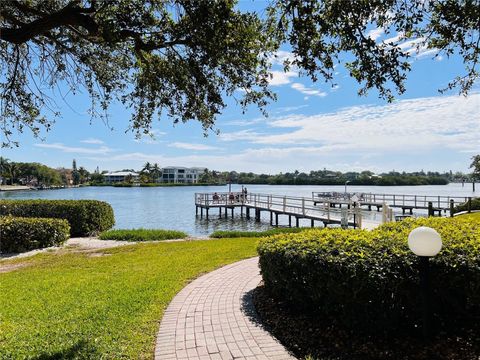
[99,229,188,241]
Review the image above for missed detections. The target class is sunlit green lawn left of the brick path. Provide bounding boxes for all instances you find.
[0,239,257,359]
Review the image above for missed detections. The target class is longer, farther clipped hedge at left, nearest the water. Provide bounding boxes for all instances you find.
[0,200,115,236]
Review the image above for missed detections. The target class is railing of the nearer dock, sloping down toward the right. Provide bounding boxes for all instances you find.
[195,192,362,225]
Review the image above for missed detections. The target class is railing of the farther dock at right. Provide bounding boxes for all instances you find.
[312,192,469,210]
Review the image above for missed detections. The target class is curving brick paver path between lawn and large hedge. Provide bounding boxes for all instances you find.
[155,258,295,360]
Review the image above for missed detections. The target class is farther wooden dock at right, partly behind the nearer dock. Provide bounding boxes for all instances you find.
[312,192,472,216]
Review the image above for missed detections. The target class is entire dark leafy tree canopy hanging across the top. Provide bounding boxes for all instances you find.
[0,0,480,146]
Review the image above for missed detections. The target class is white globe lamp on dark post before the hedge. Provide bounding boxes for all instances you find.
[408,226,442,341]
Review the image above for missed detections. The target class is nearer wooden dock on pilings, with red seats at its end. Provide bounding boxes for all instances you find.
[195,192,362,228]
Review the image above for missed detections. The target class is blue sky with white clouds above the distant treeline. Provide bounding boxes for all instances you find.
[1,3,480,174]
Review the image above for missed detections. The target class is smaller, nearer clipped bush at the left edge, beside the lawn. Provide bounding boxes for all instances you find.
[0,216,70,253]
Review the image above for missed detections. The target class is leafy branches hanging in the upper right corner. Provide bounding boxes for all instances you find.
[269,0,480,101]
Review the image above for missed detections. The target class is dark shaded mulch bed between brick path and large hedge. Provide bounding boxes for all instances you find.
[253,286,480,360]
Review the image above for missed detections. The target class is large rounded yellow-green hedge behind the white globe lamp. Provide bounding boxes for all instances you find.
[258,218,480,335]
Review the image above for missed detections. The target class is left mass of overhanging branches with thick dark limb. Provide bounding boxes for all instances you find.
[0,0,276,143]
